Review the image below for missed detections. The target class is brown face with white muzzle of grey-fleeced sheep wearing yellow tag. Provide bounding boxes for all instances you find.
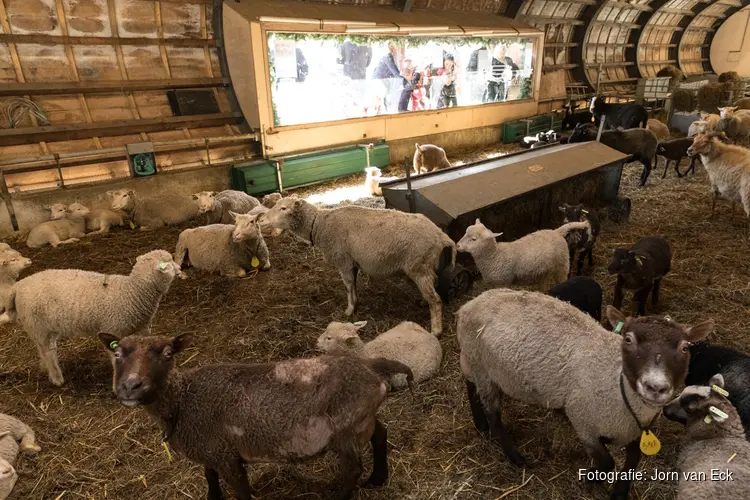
[607,306,714,407]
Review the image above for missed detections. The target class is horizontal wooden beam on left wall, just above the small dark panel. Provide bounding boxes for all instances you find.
[0,78,231,97]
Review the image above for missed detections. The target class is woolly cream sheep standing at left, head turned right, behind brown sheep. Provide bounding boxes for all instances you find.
[0,250,180,386]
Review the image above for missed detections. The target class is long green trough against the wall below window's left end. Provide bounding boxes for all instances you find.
[232,142,391,195]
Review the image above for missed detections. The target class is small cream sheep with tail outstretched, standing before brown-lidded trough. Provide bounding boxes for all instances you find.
[456,219,591,291]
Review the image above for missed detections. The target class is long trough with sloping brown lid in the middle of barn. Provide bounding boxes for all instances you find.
[381,142,630,241]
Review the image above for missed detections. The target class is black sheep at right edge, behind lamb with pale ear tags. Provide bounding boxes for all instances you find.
[685,342,750,440]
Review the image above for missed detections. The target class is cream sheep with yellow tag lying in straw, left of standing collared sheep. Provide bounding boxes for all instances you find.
[174,212,271,278]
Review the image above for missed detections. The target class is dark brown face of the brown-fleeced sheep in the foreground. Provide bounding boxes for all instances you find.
[99,333,190,408]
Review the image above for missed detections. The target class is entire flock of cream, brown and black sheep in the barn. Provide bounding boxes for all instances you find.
[0,95,750,500]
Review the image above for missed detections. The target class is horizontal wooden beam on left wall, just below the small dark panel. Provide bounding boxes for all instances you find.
[0,113,242,146]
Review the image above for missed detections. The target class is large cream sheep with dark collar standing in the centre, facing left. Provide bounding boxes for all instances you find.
[264,198,456,336]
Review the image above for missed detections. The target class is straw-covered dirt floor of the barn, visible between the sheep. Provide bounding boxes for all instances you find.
[0,142,750,500]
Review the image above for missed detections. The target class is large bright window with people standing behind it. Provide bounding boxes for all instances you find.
[268,33,534,126]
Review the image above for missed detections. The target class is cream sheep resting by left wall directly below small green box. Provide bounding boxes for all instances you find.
[107,189,198,231]
